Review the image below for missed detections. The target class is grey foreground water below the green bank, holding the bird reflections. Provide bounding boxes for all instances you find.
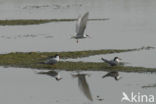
[0,67,156,104]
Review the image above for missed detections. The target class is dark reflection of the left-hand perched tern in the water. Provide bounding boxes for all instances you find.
[38,71,62,81]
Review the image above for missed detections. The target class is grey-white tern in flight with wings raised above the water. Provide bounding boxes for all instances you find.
[72,12,89,43]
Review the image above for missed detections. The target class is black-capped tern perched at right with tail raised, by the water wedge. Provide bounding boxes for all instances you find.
[101,57,121,66]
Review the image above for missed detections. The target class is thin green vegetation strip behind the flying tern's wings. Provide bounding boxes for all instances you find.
[0,18,108,25]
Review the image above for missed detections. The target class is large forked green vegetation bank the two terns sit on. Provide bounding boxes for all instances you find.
[0,47,156,72]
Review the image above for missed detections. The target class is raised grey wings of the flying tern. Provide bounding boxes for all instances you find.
[76,12,89,35]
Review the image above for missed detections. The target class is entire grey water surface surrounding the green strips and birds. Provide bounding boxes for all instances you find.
[0,0,156,104]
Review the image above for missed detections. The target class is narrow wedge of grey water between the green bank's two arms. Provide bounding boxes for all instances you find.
[63,49,156,68]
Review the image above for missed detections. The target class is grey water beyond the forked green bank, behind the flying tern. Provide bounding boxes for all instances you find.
[0,0,156,53]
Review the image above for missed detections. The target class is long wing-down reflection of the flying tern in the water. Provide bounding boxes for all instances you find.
[72,74,93,101]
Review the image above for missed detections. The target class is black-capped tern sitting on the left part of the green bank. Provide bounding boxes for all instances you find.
[44,54,60,65]
